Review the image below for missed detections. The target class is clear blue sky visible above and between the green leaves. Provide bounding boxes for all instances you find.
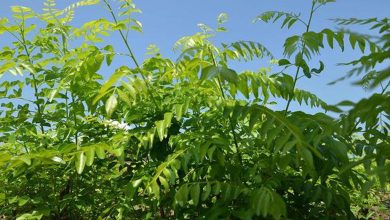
[0,0,390,112]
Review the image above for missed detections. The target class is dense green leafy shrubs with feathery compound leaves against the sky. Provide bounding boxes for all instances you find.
[0,0,390,219]
